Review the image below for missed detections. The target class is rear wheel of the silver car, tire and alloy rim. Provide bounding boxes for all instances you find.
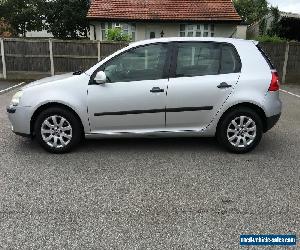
[217,107,263,154]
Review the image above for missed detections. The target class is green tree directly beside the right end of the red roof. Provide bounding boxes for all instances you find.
[233,0,269,24]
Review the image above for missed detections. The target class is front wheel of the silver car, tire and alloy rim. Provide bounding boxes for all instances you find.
[34,107,83,154]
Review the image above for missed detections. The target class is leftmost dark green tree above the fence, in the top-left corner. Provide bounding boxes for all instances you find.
[0,0,43,37]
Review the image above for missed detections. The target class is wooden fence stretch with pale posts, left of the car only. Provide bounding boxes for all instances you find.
[0,38,127,79]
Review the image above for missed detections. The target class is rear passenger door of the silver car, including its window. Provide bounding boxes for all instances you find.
[166,42,241,130]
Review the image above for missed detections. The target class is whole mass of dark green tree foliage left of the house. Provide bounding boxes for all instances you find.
[0,0,90,39]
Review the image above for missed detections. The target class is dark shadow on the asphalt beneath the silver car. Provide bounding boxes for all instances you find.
[15,136,276,154]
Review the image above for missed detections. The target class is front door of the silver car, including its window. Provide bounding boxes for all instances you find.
[88,44,169,133]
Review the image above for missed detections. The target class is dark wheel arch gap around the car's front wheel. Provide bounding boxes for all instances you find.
[30,102,84,136]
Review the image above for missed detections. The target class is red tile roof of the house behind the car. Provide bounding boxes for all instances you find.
[87,0,241,21]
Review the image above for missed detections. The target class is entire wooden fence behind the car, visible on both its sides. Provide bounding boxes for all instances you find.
[0,38,300,84]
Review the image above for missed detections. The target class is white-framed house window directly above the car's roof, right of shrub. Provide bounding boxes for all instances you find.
[179,24,215,37]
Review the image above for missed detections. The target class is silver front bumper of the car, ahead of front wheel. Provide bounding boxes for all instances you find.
[6,106,32,137]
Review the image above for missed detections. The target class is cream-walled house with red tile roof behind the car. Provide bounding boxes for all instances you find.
[87,0,246,41]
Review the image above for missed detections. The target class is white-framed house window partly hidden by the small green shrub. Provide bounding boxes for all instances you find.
[101,22,136,41]
